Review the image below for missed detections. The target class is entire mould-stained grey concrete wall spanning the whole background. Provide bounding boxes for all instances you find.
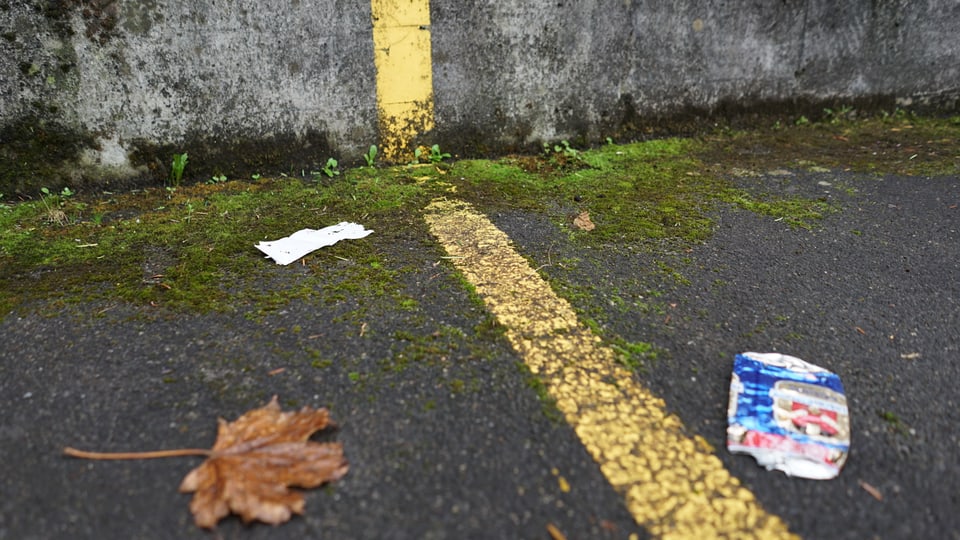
[0,0,960,196]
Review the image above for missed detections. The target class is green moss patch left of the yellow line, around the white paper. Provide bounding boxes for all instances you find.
[0,173,432,312]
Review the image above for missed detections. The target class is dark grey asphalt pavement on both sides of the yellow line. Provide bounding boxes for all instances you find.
[0,167,960,540]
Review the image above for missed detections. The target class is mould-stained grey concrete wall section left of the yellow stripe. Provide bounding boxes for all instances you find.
[0,0,377,194]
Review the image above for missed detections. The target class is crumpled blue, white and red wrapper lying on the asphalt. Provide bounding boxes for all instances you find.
[727,352,850,480]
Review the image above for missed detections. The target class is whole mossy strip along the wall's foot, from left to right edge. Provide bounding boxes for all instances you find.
[0,111,960,316]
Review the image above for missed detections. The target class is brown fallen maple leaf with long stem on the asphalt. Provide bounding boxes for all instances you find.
[64,396,349,528]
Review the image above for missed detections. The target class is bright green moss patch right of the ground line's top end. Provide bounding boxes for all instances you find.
[451,138,828,245]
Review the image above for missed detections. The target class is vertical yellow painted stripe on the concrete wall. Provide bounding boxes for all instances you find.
[370,0,433,162]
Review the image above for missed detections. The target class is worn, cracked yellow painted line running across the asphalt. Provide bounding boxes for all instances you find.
[426,199,796,539]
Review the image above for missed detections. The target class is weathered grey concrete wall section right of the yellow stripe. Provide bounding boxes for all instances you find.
[433,0,960,150]
